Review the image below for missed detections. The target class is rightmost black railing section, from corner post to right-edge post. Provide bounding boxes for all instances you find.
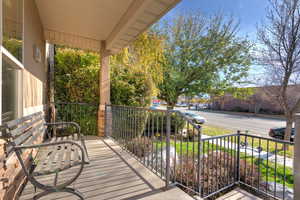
[239,134,294,199]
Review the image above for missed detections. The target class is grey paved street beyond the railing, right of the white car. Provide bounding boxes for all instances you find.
[178,108,285,136]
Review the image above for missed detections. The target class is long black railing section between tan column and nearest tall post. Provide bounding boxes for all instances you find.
[106,106,169,179]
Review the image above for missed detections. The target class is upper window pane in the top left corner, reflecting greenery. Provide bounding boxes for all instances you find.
[2,0,23,62]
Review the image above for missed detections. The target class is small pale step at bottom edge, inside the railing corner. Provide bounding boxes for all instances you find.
[217,188,262,200]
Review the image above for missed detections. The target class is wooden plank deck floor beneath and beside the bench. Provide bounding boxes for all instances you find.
[20,137,192,200]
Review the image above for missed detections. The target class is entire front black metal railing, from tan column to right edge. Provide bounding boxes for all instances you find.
[106,106,293,199]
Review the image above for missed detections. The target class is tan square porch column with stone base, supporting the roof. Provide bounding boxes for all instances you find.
[98,41,110,136]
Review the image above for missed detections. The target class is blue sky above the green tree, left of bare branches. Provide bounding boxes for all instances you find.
[163,0,269,83]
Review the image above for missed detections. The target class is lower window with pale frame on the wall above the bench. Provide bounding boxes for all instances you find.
[2,55,21,122]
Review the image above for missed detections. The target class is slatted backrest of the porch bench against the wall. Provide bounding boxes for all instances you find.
[1,112,46,157]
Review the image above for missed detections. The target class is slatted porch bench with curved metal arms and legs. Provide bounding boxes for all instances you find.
[0,112,89,199]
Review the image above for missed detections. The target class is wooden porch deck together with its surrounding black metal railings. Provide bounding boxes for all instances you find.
[20,103,292,200]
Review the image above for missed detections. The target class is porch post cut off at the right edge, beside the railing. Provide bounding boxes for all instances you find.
[294,113,300,199]
